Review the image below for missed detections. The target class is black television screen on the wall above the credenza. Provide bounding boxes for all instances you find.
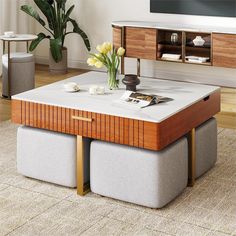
[150,0,236,17]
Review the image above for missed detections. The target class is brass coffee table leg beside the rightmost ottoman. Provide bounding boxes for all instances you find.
[188,128,196,187]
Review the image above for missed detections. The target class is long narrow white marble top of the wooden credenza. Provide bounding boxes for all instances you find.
[112,21,236,34]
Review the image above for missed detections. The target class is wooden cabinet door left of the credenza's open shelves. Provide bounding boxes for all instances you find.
[125,27,157,60]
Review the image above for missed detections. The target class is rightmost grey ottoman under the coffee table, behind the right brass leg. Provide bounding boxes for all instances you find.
[196,118,217,178]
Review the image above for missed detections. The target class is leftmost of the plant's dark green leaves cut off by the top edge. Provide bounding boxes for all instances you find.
[34,0,55,30]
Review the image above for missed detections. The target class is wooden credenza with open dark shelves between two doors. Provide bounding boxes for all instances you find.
[112,22,236,68]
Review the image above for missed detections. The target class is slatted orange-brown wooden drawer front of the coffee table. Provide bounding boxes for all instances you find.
[12,100,149,147]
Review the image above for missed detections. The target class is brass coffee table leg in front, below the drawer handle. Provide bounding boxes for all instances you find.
[77,135,90,196]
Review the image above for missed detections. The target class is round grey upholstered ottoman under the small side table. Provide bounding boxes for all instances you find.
[2,52,35,97]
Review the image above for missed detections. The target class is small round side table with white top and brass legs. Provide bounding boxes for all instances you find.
[0,34,38,99]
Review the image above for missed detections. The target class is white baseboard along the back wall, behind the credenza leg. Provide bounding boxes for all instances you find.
[36,56,236,88]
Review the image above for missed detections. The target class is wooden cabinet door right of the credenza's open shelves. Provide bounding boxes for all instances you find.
[213,33,236,68]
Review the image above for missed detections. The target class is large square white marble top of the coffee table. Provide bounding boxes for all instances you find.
[12,72,220,123]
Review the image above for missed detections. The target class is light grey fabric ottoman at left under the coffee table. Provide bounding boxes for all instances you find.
[17,126,90,188]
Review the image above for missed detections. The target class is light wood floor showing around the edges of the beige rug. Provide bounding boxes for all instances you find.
[0,65,236,129]
